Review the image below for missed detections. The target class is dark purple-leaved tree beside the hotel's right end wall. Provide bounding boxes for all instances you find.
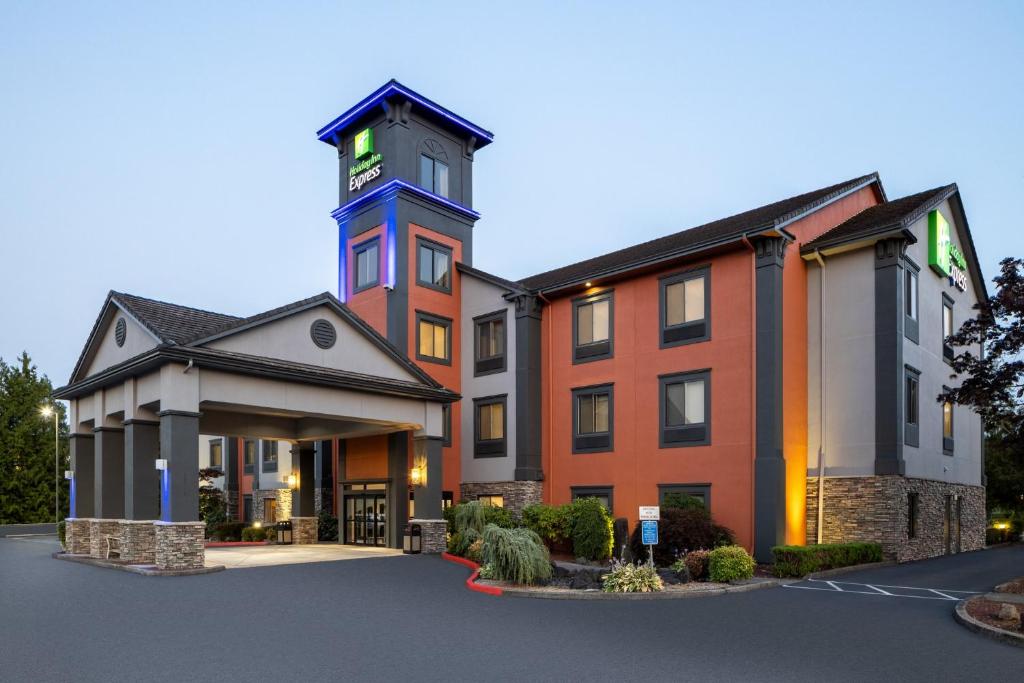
[939,258,1024,510]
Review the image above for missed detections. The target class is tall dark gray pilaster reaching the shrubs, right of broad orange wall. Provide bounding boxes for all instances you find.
[752,238,787,562]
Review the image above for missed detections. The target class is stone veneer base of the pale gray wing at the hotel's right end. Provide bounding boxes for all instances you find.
[807,476,985,562]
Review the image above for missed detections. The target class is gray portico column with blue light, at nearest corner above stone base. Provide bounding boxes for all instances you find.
[160,411,199,522]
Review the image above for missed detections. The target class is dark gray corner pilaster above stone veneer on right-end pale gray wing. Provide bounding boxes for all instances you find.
[874,239,906,474]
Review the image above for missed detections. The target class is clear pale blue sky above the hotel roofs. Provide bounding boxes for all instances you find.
[0,0,1024,385]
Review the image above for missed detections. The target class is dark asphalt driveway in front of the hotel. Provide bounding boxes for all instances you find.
[0,539,1024,683]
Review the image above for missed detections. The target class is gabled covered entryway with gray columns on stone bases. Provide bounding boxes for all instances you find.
[55,292,459,568]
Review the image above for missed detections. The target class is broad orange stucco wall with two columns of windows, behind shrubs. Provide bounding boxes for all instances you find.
[542,249,754,547]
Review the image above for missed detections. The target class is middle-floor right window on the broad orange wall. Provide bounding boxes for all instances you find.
[658,371,711,449]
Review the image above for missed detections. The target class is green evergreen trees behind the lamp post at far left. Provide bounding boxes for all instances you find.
[0,352,69,524]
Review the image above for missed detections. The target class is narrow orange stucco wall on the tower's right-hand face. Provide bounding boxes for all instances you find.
[404,223,462,498]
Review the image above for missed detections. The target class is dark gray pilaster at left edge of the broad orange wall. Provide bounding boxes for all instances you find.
[515,294,544,481]
